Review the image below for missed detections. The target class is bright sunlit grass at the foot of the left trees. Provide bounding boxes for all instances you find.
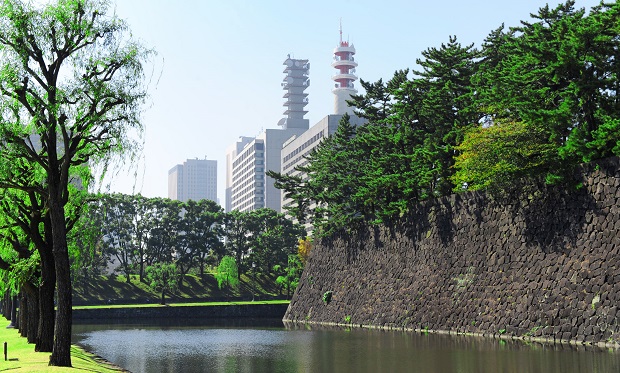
[0,318,124,373]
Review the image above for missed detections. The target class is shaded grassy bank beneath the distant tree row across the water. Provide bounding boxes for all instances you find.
[73,274,284,306]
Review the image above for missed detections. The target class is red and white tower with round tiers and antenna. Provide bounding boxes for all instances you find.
[332,23,357,114]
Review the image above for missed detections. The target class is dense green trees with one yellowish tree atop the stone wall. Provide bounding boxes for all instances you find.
[269,1,620,235]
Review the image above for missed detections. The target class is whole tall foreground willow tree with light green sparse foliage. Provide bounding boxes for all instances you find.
[0,0,151,366]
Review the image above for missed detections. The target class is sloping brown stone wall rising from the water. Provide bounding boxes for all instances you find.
[284,158,620,345]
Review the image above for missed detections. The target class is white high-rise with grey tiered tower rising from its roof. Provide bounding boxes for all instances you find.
[226,56,310,211]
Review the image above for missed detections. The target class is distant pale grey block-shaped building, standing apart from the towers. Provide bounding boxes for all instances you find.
[168,158,218,202]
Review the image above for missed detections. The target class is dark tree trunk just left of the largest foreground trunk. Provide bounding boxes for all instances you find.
[35,235,56,352]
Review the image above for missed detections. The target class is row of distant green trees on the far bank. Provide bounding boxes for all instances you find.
[72,194,305,284]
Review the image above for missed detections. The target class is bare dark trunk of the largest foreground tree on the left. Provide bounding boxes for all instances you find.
[49,198,73,367]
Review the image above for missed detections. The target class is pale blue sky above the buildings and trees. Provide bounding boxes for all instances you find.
[106,0,599,205]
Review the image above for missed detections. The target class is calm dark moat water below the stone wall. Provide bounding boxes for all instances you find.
[73,321,620,373]
